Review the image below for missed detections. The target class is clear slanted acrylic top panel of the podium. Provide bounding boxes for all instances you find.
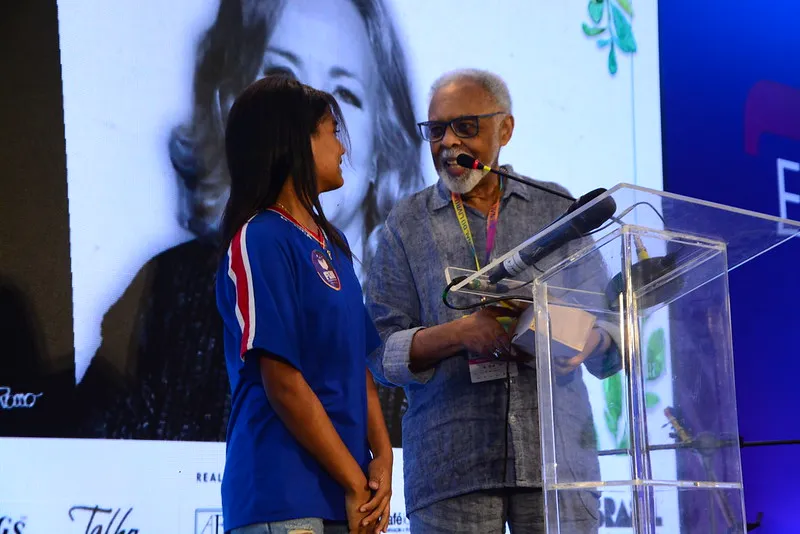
[452,183,800,291]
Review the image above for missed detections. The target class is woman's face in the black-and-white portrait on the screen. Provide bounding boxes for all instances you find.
[262,0,378,228]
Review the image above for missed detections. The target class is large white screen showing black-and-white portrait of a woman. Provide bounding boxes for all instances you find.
[0,0,664,534]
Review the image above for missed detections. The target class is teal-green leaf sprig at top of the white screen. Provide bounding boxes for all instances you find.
[583,0,636,76]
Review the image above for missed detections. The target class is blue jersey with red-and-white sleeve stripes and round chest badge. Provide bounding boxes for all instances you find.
[217,211,380,530]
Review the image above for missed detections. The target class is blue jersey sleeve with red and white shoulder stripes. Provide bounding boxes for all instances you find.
[228,223,302,371]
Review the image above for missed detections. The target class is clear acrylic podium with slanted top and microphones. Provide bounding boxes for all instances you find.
[446,184,800,534]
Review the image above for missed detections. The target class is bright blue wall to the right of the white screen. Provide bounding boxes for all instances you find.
[659,0,800,534]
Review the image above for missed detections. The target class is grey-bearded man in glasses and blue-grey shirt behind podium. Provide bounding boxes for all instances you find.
[366,70,619,534]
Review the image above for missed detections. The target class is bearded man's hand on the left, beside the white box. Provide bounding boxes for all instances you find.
[460,306,527,361]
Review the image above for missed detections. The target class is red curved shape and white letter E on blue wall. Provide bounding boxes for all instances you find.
[744,80,800,235]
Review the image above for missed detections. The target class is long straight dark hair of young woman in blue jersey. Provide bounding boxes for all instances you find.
[222,76,351,259]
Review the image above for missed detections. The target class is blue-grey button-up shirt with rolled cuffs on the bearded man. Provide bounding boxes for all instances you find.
[366,166,619,521]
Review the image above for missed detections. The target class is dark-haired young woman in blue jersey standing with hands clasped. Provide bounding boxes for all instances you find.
[217,76,392,534]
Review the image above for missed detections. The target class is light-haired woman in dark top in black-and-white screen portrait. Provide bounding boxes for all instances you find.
[75,0,416,447]
